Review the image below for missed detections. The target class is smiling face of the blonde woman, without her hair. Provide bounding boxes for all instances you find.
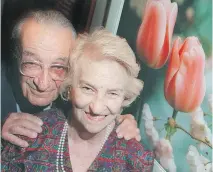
[71,59,128,133]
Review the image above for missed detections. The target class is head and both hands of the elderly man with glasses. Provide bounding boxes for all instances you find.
[2,11,140,147]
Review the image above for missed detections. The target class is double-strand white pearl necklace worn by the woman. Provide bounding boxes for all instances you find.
[56,121,112,172]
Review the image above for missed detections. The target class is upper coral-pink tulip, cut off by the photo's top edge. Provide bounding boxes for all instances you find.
[137,0,178,69]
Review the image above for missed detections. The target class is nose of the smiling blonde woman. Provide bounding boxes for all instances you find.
[89,96,107,115]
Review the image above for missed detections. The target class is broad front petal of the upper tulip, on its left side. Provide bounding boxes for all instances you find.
[137,1,166,67]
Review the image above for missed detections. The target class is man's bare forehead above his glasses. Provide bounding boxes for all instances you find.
[21,19,75,57]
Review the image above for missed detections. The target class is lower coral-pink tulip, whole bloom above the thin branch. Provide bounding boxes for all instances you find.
[164,37,205,112]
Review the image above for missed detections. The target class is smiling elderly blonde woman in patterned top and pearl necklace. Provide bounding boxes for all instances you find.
[2,29,153,172]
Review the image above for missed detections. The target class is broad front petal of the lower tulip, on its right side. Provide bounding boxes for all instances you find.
[169,48,204,111]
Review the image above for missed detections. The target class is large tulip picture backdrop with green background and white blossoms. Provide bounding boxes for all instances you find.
[117,0,212,172]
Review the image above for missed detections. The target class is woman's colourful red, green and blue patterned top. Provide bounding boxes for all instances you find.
[1,109,154,172]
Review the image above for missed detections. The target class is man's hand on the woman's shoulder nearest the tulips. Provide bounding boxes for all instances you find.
[116,114,141,141]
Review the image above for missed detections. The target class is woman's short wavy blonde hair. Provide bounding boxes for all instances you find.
[61,29,143,106]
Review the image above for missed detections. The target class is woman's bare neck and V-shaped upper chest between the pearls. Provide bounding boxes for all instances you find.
[68,115,115,172]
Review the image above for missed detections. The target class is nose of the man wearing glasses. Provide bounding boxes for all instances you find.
[34,69,51,91]
